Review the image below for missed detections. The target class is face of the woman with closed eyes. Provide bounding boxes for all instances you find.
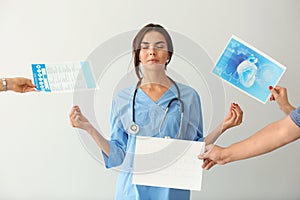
[139,31,169,69]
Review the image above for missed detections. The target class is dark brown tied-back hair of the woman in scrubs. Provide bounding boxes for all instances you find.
[132,23,173,79]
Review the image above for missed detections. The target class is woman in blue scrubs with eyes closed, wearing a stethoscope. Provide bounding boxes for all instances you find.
[69,24,243,200]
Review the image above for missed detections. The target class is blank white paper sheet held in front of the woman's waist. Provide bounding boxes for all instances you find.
[133,136,205,191]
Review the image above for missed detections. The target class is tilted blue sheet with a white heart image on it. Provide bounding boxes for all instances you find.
[212,36,286,103]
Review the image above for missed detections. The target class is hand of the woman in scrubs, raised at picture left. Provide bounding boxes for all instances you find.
[69,106,92,131]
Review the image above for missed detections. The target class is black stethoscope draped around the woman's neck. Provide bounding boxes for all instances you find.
[129,77,184,138]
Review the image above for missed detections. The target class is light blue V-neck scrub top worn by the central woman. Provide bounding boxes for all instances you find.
[103,83,203,200]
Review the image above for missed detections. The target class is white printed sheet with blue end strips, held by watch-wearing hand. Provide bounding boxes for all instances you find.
[31,62,98,92]
